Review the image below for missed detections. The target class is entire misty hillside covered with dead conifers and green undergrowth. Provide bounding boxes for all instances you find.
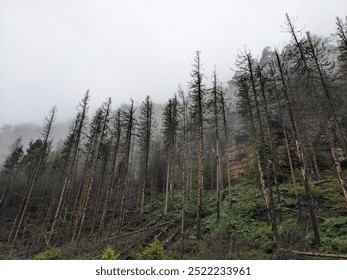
[0,14,347,259]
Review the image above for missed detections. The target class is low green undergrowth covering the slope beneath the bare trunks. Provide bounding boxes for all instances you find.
[35,176,347,260]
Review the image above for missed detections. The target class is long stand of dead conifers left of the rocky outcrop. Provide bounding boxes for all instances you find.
[0,48,231,256]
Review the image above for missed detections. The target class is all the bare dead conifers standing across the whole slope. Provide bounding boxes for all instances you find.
[0,16,347,258]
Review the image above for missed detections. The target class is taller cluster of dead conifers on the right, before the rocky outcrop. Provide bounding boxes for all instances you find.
[233,15,347,247]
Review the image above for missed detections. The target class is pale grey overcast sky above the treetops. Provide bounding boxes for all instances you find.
[0,0,347,126]
